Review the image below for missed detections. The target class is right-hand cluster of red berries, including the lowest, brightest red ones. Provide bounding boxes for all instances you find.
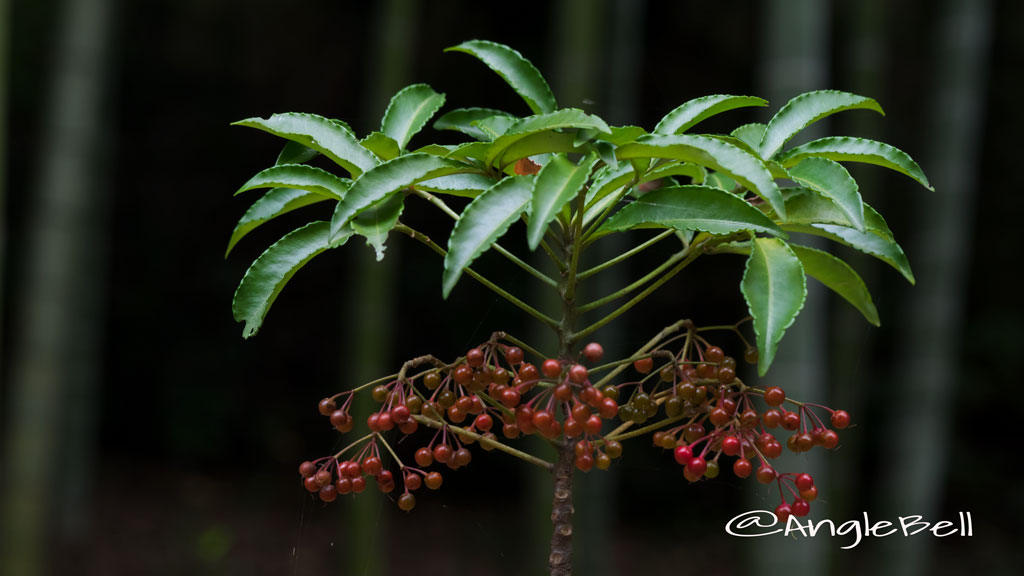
[621,338,850,520]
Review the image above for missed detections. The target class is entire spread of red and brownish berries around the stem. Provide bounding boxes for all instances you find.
[299,326,850,520]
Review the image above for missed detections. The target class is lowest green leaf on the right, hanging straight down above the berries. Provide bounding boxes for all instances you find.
[739,238,807,376]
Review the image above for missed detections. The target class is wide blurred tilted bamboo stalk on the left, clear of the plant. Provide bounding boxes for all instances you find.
[0,0,114,576]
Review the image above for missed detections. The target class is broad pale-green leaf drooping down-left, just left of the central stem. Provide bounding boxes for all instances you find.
[441,176,534,298]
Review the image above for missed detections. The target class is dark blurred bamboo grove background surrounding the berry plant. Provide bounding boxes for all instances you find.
[0,0,1024,576]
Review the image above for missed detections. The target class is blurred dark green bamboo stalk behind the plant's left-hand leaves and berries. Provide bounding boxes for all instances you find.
[342,0,420,576]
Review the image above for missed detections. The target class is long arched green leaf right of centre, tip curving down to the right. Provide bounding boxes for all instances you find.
[615,134,785,217]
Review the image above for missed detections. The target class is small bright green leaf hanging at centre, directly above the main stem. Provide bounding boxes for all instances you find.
[526,154,597,250]
